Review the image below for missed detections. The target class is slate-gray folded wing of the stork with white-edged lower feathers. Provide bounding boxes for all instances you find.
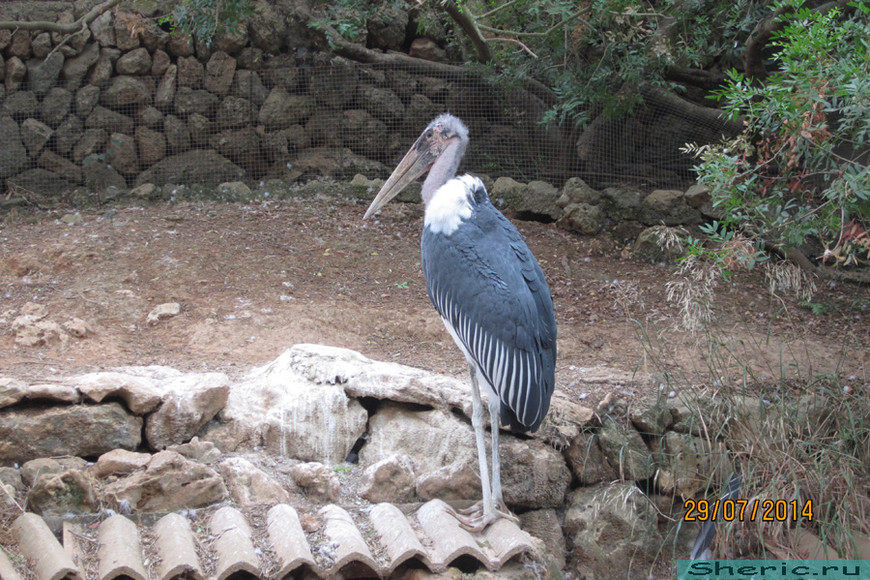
[421,192,556,431]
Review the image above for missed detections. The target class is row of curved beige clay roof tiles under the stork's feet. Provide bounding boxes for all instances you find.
[0,500,534,580]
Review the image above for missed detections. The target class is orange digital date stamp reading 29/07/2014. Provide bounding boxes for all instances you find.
[683,499,813,522]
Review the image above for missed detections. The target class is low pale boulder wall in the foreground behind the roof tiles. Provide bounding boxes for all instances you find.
[0,344,740,578]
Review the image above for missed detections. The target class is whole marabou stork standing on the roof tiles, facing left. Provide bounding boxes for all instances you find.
[365,114,556,531]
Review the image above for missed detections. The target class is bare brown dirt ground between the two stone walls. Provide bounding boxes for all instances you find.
[0,197,870,403]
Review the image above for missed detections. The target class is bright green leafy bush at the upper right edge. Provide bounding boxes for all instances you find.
[689,0,870,266]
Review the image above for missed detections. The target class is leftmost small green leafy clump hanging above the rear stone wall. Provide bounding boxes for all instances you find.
[160,0,251,42]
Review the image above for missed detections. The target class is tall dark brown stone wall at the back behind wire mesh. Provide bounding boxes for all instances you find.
[0,2,584,201]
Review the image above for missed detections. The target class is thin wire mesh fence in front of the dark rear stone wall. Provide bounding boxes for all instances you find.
[0,5,744,208]
